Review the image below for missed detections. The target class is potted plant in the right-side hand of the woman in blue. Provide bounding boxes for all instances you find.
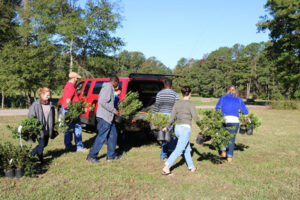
[240,112,262,135]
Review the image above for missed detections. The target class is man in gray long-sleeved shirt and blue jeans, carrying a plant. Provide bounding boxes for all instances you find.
[86,76,120,162]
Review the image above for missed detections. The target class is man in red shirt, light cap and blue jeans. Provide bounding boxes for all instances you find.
[62,72,88,152]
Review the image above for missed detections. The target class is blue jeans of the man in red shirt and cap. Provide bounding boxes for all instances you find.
[62,107,84,151]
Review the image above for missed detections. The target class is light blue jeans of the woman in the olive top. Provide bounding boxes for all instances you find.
[165,125,195,169]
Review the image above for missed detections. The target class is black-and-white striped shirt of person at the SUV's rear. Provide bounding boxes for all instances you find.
[153,88,179,114]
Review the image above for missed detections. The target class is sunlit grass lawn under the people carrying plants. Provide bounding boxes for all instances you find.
[0,109,300,200]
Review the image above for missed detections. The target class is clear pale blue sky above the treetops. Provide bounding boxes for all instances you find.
[81,0,269,69]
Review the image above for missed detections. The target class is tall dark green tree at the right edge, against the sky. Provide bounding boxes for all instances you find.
[257,0,300,98]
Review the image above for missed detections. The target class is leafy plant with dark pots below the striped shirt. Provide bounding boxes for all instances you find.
[144,110,171,142]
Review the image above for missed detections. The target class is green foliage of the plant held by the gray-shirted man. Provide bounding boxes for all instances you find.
[118,91,143,120]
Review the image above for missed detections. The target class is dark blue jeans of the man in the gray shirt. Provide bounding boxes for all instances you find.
[89,117,118,159]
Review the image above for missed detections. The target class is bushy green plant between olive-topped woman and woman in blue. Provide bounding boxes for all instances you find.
[196,110,233,150]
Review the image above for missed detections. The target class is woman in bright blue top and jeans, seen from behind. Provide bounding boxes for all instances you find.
[215,86,248,162]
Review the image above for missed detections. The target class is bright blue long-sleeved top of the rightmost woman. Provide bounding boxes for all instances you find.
[215,94,248,117]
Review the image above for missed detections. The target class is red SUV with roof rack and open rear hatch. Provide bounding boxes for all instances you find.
[58,73,171,131]
